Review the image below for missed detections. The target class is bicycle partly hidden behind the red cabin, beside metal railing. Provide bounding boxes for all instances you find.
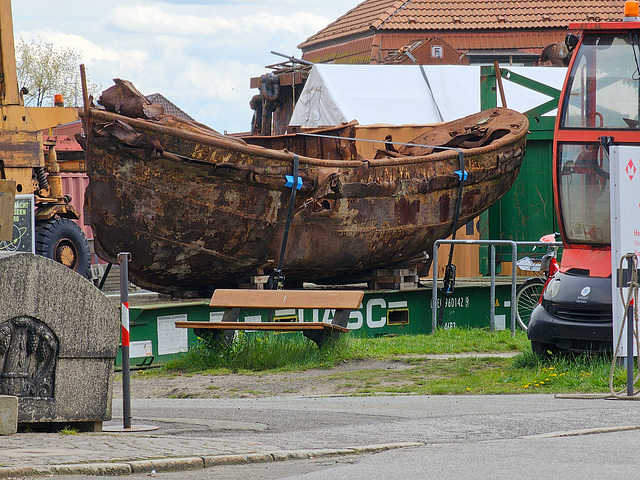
[516,233,560,332]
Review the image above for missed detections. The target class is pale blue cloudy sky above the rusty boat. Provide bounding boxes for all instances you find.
[12,0,362,133]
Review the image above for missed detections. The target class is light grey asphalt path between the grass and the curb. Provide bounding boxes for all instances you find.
[113,395,640,449]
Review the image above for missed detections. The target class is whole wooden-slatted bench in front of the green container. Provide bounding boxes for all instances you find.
[175,289,364,347]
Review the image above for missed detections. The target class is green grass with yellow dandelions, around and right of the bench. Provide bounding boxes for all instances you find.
[160,329,626,395]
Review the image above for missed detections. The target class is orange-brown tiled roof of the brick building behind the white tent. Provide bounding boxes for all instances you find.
[298,0,624,51]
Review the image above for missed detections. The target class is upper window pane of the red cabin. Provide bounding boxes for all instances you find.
[561,32,640,129]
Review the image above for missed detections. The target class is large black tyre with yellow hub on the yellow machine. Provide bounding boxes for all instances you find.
[36,218,91,278]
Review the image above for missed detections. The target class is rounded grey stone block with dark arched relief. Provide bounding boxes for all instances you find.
[0,254,120,424]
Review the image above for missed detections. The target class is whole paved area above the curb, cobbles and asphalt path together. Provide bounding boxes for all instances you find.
[0,394,640,479]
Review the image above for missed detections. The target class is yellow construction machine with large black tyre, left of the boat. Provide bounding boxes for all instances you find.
[0,0,90,277]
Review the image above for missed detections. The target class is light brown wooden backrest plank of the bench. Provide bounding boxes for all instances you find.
[209,288,364,310]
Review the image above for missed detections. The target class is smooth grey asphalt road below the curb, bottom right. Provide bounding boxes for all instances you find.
[94,430,640,480]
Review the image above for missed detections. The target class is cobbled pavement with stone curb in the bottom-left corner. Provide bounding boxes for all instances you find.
[0,422,420,478]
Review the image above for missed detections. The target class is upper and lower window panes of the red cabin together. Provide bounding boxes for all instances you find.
[556,31,640,246]
